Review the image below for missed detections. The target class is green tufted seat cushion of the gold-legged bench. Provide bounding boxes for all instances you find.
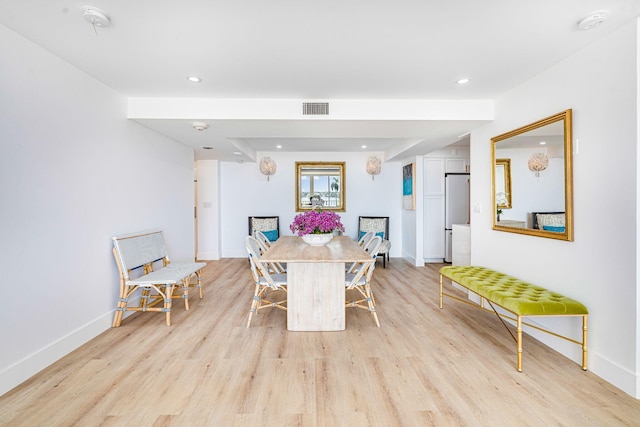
[440,266,589,316]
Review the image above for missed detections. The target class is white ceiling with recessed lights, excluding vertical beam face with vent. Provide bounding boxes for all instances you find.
[0,0,640,160]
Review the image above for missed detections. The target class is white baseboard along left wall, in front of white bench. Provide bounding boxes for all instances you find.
[0,311,114,396]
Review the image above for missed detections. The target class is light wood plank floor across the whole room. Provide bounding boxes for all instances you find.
[0,259,640,427]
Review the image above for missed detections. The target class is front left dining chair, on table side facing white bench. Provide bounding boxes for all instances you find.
[246,236,287,328]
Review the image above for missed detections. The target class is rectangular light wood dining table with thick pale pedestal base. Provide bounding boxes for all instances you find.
[259,236,372,331]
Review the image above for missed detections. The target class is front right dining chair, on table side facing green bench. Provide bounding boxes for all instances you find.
[345,236,382,327]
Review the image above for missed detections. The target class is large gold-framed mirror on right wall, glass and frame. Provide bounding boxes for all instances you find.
[491,110,573,241]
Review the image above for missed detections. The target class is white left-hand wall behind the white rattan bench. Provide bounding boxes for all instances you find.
[0,25,194,394]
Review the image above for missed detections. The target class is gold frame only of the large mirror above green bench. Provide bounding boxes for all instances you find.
[491,109,573,241]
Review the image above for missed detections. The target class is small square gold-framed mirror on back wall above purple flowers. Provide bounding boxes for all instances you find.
[296,162,347,212]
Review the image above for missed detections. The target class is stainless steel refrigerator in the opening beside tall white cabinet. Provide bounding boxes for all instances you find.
[444,173,470,262]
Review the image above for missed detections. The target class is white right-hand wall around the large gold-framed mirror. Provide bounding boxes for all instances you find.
[471,22,640,397]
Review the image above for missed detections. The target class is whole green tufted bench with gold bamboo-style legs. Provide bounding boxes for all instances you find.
[440,265,589,372]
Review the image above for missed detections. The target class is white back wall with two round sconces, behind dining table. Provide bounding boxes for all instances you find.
[220,152,402,258]
